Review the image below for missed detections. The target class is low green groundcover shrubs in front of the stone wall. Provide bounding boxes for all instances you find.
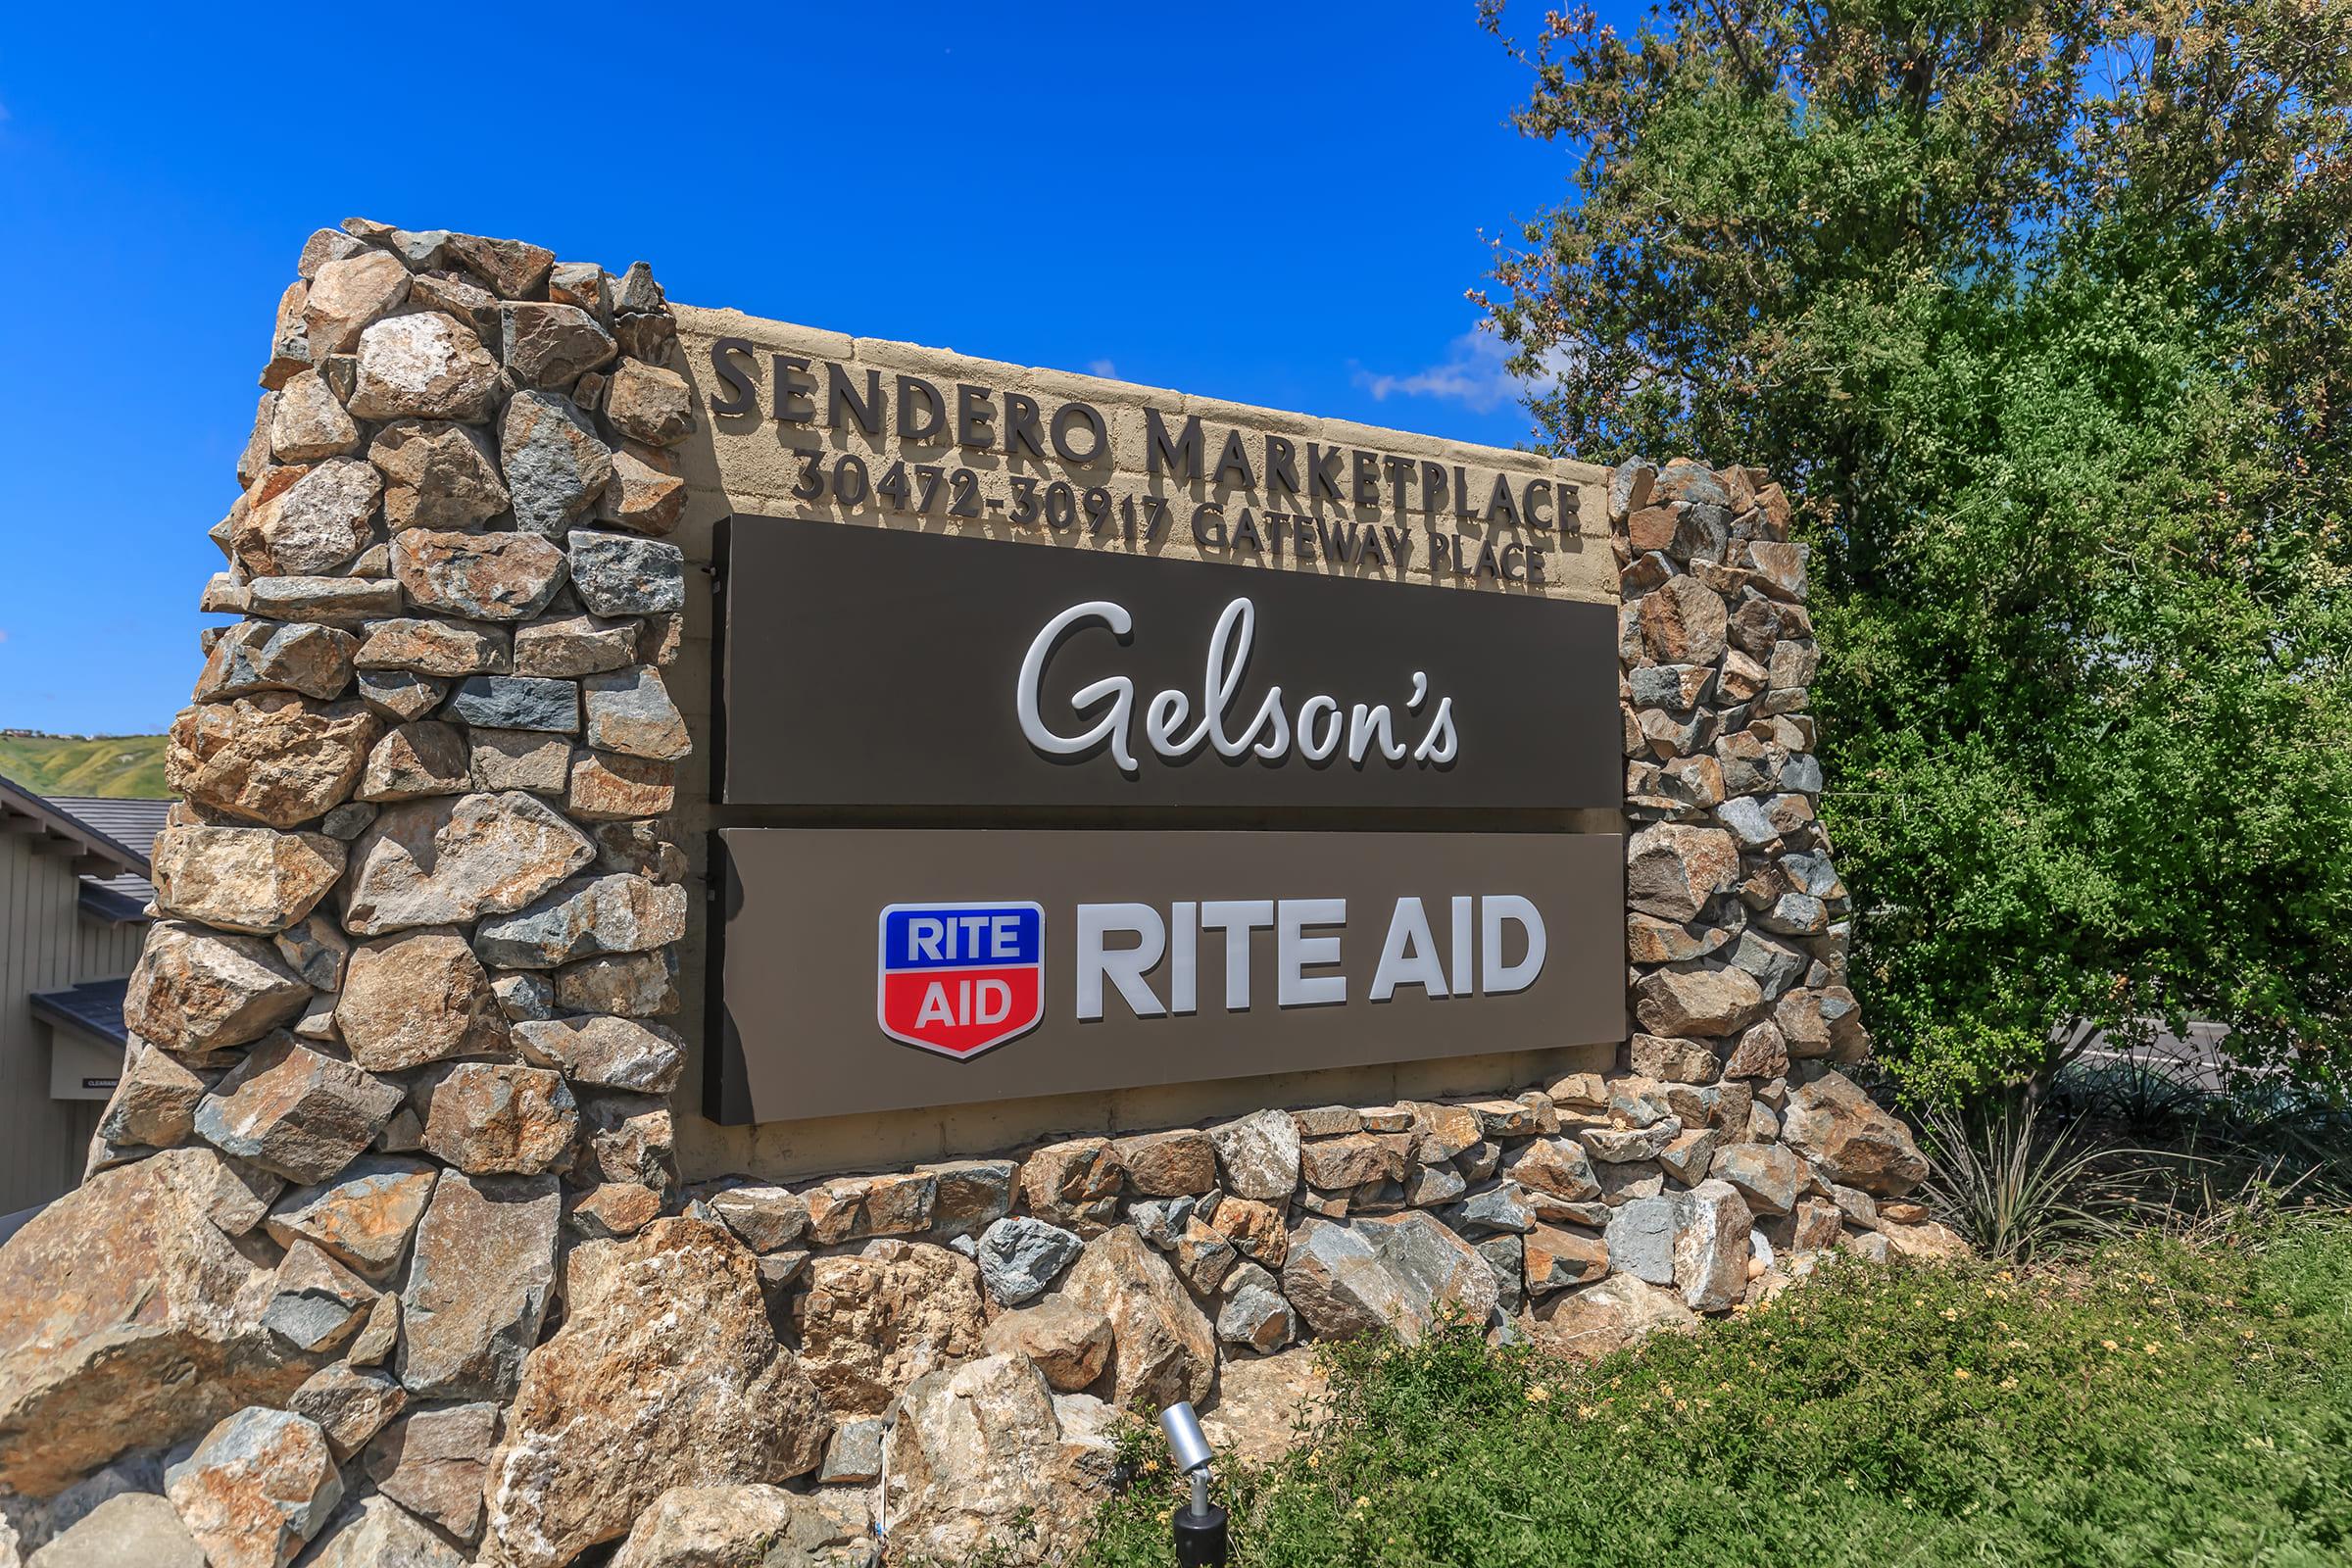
[1092,1210,2352,1568]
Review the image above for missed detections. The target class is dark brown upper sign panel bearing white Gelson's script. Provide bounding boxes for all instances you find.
[722,517,1623,823]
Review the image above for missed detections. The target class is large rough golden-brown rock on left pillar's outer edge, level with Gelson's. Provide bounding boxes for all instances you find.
[165,691,376,827]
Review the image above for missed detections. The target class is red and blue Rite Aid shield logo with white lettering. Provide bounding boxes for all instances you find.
[875,903,1045,1057]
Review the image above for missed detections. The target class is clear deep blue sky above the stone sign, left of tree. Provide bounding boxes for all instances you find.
[0,0,1618,733]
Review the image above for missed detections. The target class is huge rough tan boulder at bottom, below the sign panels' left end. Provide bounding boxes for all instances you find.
[482,1218,832,1568]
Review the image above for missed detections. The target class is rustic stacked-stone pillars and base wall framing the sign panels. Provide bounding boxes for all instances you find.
[0,220,1954,1568]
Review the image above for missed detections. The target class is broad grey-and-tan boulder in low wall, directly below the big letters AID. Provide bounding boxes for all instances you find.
[1282,1210,1495,1343]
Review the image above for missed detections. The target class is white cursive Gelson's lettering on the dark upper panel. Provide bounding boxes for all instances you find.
[1013,597,1460,776]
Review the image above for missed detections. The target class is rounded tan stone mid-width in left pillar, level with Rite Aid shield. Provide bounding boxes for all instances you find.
[334,926,506,1072]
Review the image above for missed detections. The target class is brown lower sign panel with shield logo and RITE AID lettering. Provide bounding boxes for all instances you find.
[708,827,1625,1121]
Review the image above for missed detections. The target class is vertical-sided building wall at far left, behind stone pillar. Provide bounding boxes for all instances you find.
[0,832,146,1213]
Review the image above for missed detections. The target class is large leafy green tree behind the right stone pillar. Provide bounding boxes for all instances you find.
[1475,0,2352,1096]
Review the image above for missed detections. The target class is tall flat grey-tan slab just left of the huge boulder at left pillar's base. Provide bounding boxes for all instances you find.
[395,1171,563,1398]
